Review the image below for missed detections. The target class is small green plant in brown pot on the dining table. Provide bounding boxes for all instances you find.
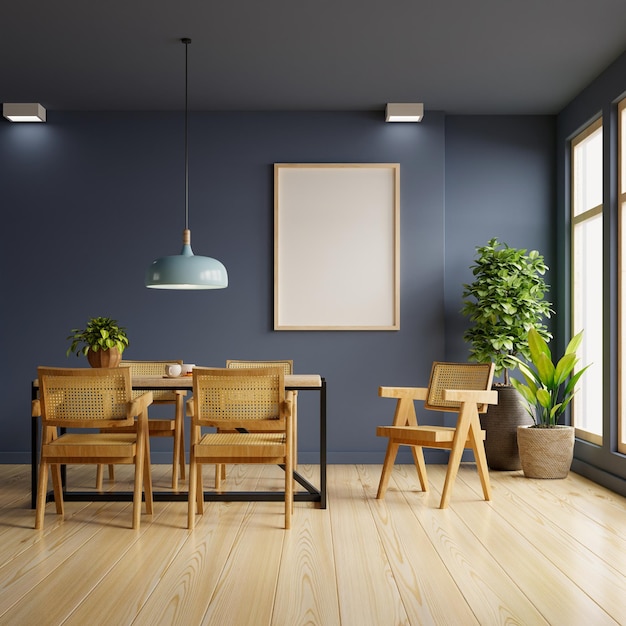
[66,317,128,367]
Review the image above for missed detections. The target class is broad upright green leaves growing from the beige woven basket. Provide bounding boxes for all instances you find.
[511,328,590,428]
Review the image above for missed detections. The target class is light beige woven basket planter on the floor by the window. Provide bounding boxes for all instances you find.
[517,426,574,478]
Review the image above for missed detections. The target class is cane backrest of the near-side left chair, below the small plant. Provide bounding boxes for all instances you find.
[37,367,133,428]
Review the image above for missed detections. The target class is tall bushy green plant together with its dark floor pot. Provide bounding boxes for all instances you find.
[461,238,553,470]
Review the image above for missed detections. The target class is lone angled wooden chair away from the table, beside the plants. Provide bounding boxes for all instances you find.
[376,362,498,509]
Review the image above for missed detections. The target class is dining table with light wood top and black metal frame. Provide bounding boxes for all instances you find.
[31,374,327,509]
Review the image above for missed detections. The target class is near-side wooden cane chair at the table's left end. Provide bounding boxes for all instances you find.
[33,367,152,529]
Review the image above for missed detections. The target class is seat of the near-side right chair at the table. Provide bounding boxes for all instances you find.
[196,432,286,463]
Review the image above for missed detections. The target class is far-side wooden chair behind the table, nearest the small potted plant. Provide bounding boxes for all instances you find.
[96,360,187,490]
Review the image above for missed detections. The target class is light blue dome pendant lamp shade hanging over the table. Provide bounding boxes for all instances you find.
[146,229,228,290]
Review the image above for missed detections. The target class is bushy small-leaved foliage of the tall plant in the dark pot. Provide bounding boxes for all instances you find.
[461,238,553,385]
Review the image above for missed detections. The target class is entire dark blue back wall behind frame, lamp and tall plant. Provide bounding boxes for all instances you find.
[0,111,554,463]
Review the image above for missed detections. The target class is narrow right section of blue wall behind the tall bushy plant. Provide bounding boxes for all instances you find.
[445,116,557,360]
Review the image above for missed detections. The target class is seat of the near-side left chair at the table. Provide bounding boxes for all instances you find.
[43,433,137,459]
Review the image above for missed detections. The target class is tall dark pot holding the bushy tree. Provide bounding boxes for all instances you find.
[480,385,533,471]
